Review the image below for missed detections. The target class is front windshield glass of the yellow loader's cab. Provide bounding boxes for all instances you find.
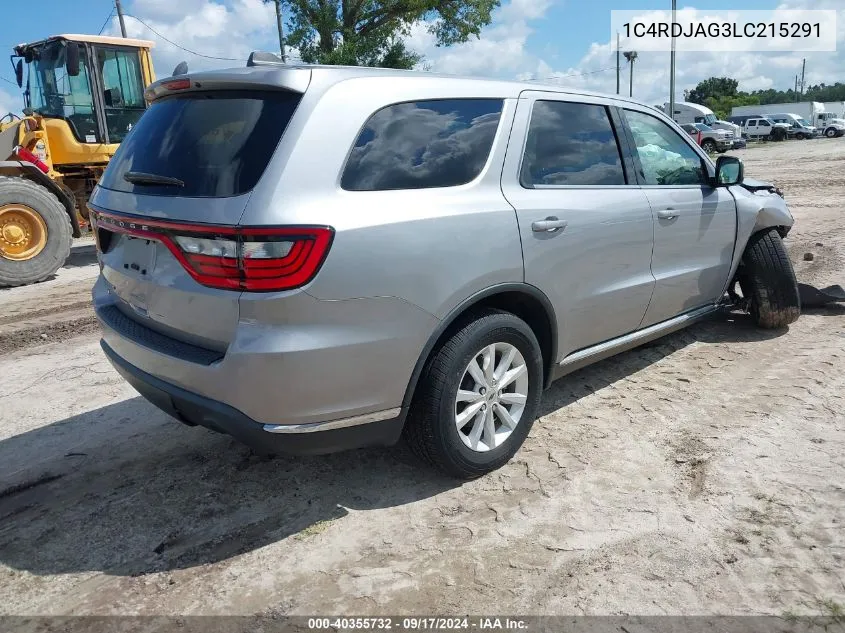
[27,40,99,143]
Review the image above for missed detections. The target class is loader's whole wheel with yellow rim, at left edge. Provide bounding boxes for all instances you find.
[0,176,73,286]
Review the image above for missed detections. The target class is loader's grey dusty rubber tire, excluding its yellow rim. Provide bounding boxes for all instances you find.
[0,176,73,286]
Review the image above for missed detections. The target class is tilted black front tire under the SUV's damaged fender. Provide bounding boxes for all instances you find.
[739,229,801,329]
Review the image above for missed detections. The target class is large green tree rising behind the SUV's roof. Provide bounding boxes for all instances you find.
[264,0,500,68]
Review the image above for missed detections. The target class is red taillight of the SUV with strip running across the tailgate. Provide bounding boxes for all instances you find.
[94,211,334,292]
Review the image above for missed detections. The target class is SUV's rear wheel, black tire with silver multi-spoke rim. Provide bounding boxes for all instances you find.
[404,310,543,479]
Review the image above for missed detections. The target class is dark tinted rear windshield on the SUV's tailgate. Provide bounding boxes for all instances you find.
[100,91,301,198]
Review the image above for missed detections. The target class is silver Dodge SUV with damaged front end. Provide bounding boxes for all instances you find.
[90,54,799,478]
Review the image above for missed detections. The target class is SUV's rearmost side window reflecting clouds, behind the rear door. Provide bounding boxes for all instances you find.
[340,99,503,191]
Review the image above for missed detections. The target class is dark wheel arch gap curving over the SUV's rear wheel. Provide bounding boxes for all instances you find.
[402,283,558,418]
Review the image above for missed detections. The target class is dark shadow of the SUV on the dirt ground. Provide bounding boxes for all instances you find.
[0,306,782,576]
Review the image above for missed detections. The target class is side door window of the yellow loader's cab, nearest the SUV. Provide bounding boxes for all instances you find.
[96,47,145,143]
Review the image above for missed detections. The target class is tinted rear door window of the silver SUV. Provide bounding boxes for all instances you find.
[520,101,625,188]
